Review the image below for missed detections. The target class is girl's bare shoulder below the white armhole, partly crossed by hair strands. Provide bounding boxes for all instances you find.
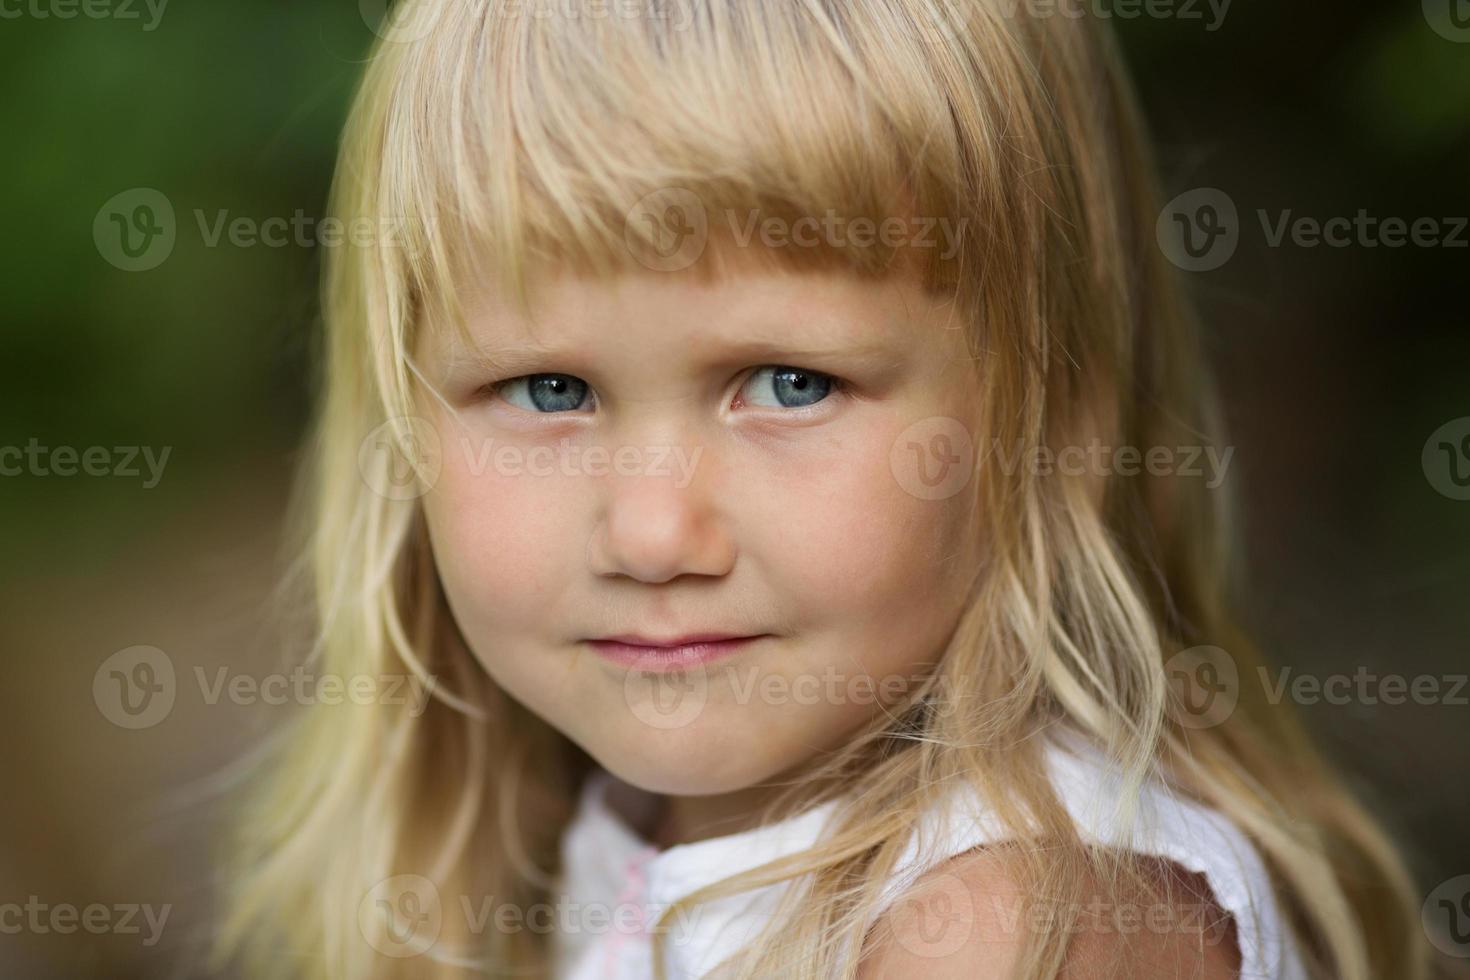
[857,848,1241,980]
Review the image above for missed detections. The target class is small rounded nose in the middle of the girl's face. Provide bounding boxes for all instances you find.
[588,452,736,585]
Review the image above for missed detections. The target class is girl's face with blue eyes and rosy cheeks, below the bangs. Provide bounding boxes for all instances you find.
[422,258,976,795]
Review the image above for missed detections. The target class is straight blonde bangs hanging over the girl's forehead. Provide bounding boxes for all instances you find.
[348,0,973,337]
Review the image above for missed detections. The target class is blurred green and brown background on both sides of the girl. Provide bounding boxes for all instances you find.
[0,0,1470,977]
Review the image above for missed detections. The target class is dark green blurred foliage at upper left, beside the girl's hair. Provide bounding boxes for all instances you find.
[0,3,370,561]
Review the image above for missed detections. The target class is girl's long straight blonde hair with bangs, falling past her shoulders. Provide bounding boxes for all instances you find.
[218,0,1429,980]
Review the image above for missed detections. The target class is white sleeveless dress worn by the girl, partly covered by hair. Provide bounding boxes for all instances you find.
[553,738,1307,980]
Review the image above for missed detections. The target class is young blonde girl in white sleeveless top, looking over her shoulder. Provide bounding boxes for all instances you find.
[218,0,1446,980]
